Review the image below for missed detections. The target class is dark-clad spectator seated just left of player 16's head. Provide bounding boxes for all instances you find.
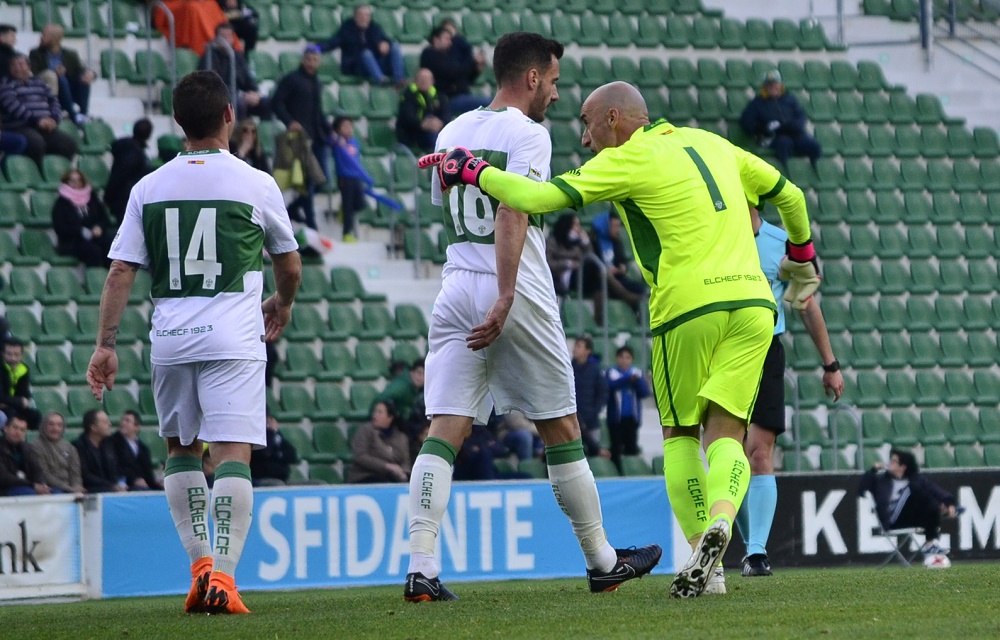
[420,22,491,117]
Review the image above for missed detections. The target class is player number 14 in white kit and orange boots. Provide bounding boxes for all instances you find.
[87,71,302,614]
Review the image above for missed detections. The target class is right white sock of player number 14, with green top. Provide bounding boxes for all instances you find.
[212,462,253,576]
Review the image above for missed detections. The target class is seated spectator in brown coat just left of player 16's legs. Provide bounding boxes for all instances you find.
[347,400,413,484]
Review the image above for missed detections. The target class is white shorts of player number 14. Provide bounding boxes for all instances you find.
[152,360,267,449]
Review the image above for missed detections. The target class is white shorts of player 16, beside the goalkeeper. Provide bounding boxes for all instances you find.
[424,271,576,423]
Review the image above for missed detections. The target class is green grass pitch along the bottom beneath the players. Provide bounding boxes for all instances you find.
[2,562,1000,640]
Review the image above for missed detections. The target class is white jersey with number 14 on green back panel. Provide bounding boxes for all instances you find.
[108,150,298,365]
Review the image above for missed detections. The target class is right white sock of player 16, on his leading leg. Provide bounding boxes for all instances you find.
[549,459,618,571]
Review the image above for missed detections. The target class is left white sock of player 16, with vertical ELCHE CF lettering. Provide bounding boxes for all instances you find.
[407,453,453,578]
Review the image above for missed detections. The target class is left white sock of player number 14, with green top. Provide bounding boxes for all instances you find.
[163,456,212,564]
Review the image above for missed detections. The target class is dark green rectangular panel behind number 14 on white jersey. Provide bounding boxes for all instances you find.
[142,200,264,298]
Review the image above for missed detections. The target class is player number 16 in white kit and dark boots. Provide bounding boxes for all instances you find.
[403,32,662,602]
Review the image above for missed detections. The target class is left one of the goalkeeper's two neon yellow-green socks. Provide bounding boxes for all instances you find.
[663,437,709,540]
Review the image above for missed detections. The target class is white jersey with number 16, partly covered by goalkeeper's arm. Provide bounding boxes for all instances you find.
[431,107,559,319]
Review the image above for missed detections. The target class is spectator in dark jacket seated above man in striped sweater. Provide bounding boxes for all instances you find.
[28,24,97,125]
